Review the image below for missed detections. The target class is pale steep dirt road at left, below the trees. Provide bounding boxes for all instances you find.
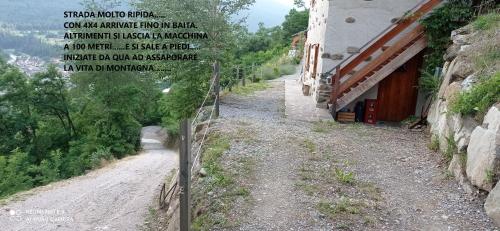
[0,127,178,231]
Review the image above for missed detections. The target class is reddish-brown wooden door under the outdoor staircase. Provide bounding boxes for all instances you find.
[377,53,422,122]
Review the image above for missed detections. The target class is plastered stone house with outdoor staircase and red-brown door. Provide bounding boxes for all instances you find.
[301,0,440,121]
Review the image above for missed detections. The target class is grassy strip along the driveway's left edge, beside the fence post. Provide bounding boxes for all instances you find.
[192,132,255,230]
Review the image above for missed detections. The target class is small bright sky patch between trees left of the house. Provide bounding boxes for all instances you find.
[241,0,293,32]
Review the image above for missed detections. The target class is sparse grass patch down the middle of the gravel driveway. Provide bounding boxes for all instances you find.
[295,137,383,227]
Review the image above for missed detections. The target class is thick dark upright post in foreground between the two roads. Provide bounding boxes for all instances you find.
[179,120,191,231]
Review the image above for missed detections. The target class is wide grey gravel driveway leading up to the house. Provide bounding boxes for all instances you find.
[213,76,497,230]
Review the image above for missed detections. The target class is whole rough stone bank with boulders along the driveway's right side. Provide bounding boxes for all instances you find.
[428,23,500,226]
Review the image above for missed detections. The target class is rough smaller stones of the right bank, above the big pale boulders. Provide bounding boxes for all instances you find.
[428,26,490,156]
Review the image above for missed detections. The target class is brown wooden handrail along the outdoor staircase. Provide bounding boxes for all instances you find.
[327,0,442,115]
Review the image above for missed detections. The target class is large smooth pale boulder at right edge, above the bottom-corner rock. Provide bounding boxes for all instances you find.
[467,104,500,191]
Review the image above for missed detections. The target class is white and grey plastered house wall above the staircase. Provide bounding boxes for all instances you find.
[303,0,421,108]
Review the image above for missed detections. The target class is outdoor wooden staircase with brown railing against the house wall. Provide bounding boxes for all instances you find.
[327,0,442,114]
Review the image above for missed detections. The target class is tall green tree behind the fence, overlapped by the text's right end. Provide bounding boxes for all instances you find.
[137,0,255,133]
